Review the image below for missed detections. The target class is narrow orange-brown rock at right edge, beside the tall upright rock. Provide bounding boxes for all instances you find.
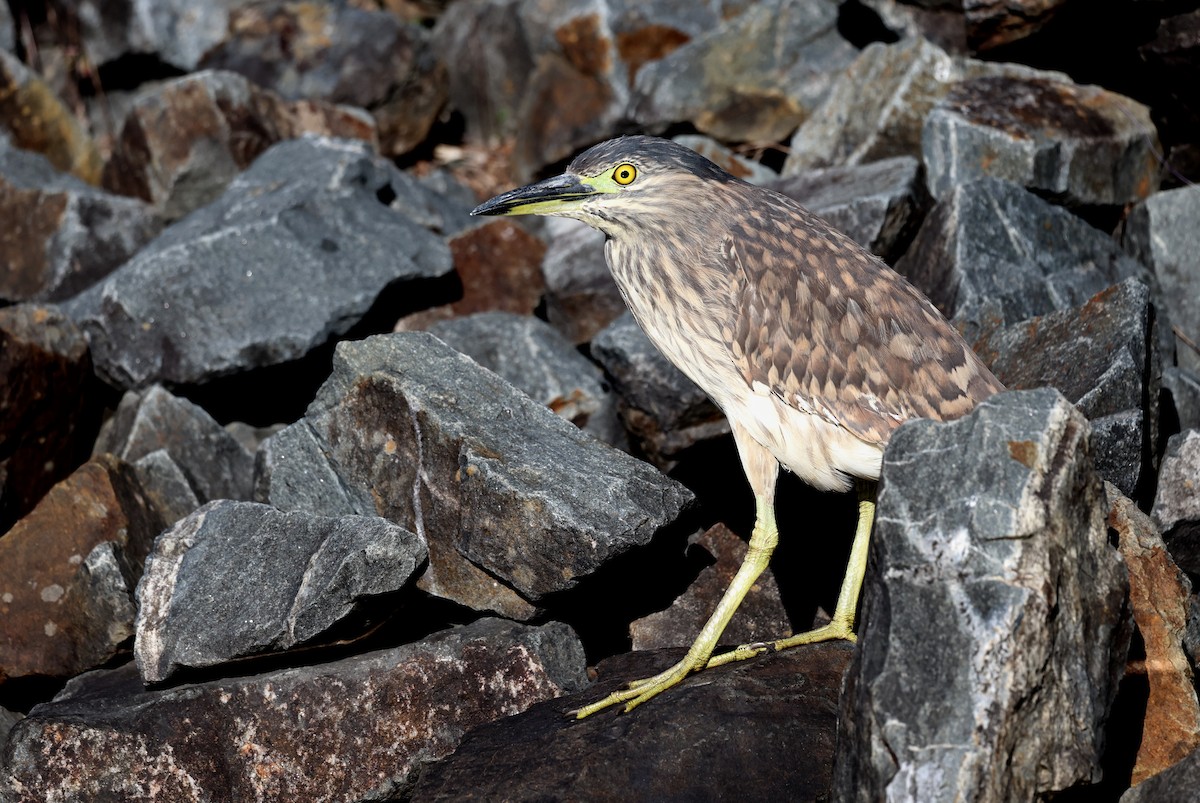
[1109,486,1200,785]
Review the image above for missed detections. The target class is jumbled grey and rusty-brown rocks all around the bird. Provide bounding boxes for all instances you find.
[0,0,1200,803]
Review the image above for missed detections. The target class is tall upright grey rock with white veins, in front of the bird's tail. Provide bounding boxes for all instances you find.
[832,389,1129,801]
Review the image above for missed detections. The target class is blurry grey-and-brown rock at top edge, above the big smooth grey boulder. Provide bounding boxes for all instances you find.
[200,0,446,156]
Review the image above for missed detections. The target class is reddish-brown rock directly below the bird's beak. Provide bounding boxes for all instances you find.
[396,220,546,331]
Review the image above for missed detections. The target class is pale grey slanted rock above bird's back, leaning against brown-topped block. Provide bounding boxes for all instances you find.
[784,37,1067,175]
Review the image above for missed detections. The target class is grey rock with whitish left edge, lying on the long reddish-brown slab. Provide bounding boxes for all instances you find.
[133,501,427,683]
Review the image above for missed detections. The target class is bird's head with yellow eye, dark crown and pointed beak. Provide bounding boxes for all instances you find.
[470,136,737,235]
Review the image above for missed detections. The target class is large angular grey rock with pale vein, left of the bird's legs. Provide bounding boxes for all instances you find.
[256,332,692,618]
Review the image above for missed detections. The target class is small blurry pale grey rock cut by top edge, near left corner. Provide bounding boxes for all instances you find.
[74,0,245,72]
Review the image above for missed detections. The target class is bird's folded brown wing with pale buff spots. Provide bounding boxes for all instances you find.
[721,202,1003,445]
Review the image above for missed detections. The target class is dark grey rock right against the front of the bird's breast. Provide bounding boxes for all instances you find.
[592,312,730,471]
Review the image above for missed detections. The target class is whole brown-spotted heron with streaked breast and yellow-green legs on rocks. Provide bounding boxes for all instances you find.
[472,137,1003,718]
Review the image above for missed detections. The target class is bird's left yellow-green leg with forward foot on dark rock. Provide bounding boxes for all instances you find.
[572,496,779,719]
